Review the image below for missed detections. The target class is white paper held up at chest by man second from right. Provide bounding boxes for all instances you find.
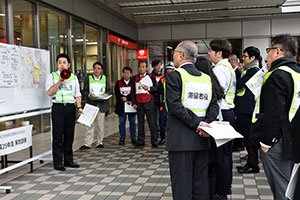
[246,67,268,98]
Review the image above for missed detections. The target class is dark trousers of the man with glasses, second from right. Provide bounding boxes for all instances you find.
[236,114,258,167]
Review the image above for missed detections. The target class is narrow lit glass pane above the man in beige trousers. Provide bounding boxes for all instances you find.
[85,25,99,74]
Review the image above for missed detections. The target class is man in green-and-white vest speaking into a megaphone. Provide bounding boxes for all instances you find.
[46,54,83,171]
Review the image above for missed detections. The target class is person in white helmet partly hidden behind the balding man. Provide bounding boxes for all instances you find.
[157,62,175,144]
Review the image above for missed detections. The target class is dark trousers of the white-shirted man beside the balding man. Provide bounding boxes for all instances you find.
[215,109,236,195]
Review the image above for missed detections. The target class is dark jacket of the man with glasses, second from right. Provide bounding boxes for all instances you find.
[234,68,259,115]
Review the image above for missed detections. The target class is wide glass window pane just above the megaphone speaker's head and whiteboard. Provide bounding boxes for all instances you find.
[39,6,68,54]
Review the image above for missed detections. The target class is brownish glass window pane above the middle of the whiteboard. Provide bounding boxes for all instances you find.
[13,0,34,47]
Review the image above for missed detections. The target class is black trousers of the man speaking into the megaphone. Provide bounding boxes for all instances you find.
[51,103,76,166]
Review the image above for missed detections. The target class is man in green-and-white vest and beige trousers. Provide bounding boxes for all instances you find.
[80,62,110,150]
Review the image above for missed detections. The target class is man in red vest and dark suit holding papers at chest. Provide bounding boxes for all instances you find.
[131,61,158,147]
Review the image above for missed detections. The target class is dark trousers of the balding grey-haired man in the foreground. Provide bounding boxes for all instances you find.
[169,150,209,200]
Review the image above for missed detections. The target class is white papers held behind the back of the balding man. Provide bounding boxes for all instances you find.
[200,121,243,147]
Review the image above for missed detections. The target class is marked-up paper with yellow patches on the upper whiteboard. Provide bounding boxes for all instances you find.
[0,44,49,88]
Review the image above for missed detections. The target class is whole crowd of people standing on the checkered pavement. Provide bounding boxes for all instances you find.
[46,35,300,200]
